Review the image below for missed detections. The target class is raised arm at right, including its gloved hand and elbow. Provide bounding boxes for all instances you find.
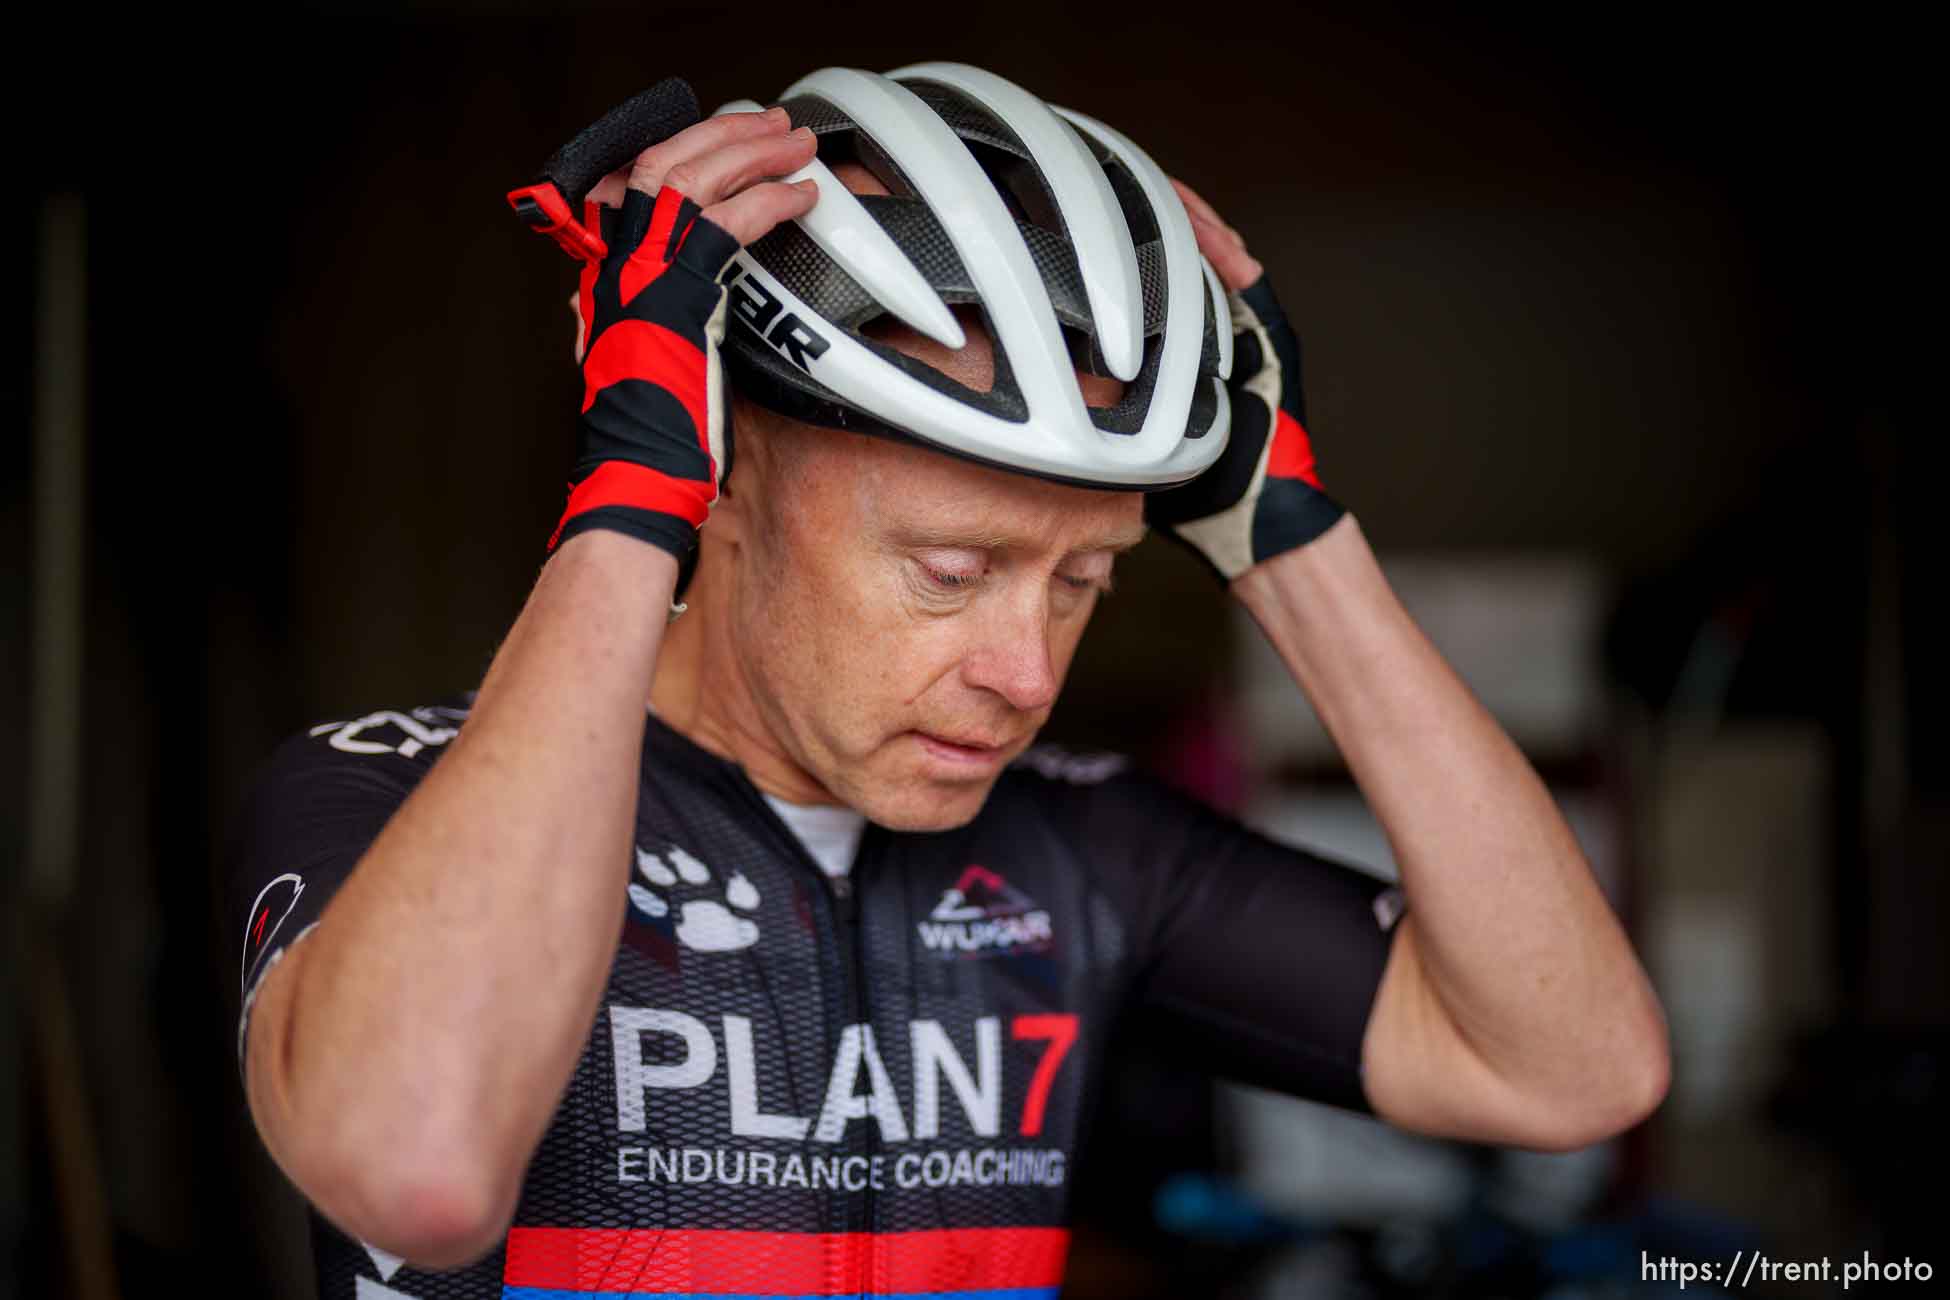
[1147,183,1669,1150]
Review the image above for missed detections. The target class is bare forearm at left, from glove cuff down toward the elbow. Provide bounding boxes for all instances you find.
[277,530,677,1239]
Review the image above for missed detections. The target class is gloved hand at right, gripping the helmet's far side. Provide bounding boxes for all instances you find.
[1145,179,1346,583]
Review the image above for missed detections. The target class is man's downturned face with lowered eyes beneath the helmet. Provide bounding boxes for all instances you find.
[735,311,1145,830]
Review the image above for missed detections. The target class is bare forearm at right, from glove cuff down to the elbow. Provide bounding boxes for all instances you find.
[1232,516,1663,1111]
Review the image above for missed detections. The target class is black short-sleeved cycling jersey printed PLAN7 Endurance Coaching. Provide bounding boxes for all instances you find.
[230,696,1400,1300]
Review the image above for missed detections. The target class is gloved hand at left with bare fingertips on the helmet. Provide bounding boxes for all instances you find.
[548,109,819,598]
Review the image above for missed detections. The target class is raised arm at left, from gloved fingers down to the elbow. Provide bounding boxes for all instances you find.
[246,111,817,1267]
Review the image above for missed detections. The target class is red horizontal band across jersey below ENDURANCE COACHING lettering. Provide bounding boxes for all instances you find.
[501,1228,1071,1296]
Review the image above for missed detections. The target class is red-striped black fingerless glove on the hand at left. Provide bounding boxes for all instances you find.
[548,185,737,598]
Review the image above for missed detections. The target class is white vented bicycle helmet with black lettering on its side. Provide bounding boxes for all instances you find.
[718,62,1232,489]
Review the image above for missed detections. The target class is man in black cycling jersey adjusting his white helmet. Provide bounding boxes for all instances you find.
[224,64,1667,1296]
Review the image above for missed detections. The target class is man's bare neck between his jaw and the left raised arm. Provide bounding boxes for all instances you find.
[649,546,839,803]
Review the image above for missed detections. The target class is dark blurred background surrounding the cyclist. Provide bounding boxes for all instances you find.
[11,0,1950,1298]
